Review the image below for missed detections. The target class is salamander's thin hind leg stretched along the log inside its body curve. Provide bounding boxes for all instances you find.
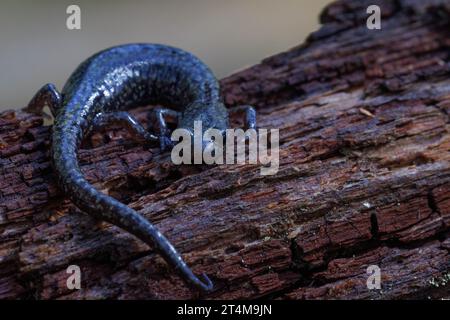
[90,111,159,143]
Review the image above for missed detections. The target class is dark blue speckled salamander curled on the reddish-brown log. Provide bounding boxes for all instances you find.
[26,44,256,291]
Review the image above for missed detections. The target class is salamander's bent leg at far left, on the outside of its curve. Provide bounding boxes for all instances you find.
[25,83,62,118]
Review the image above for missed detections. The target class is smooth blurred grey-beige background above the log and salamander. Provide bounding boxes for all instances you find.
[0,0,331,110]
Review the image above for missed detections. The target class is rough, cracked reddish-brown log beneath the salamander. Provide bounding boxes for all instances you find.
[0,0,450,299]
